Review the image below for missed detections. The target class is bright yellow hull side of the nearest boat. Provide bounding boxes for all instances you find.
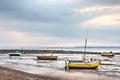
[66,61,99,69]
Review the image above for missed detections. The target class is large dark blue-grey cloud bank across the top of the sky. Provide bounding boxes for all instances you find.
[0,0,119,24]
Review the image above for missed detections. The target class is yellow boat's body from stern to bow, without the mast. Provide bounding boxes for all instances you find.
[65,60,99,69]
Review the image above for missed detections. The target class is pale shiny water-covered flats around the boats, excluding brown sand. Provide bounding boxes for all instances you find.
[0,54,120,80]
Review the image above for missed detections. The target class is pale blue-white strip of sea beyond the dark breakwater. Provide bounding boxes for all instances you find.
[0,46,120,53]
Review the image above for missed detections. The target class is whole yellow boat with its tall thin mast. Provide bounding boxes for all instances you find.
[65,31,100,69]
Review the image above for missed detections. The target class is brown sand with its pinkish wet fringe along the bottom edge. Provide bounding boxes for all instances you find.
[0,67,104,80]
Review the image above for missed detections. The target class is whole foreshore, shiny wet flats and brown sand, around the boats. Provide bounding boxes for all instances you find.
[0,53,120,80]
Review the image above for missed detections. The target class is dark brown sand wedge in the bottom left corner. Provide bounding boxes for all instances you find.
[0,67,63,80]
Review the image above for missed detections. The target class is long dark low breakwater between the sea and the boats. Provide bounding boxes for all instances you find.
[0,49,120,54]
